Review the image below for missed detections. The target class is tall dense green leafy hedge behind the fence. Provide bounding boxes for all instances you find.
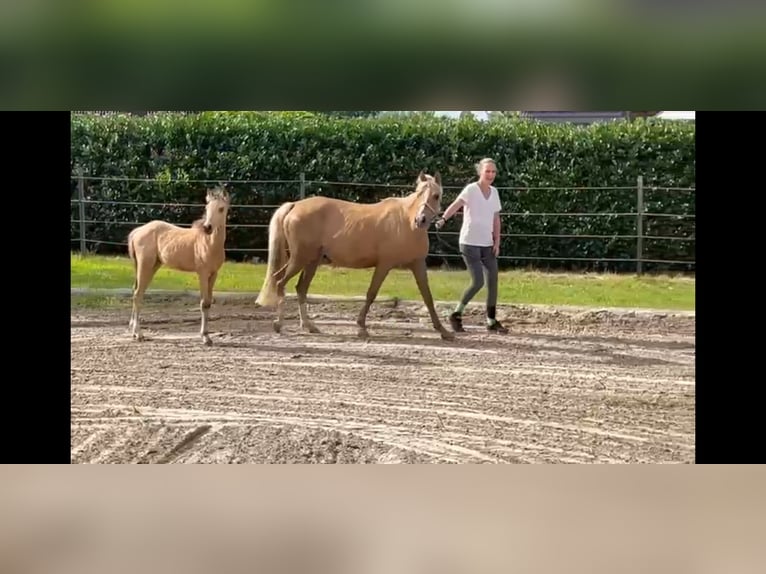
[71,112,695,271]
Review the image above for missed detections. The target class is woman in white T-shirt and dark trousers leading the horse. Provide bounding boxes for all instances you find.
[435,158,508,333]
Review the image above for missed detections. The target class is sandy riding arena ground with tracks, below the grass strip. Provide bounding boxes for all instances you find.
[71,294,695,463]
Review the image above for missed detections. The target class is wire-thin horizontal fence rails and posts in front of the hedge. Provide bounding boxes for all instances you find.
[70,174,696,274]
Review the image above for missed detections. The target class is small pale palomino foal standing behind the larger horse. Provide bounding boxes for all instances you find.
[128,188,229,345]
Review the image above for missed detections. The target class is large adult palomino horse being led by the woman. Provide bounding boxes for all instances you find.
[256,171,454,339]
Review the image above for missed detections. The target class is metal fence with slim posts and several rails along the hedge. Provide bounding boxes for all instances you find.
[70,174,696,274]
